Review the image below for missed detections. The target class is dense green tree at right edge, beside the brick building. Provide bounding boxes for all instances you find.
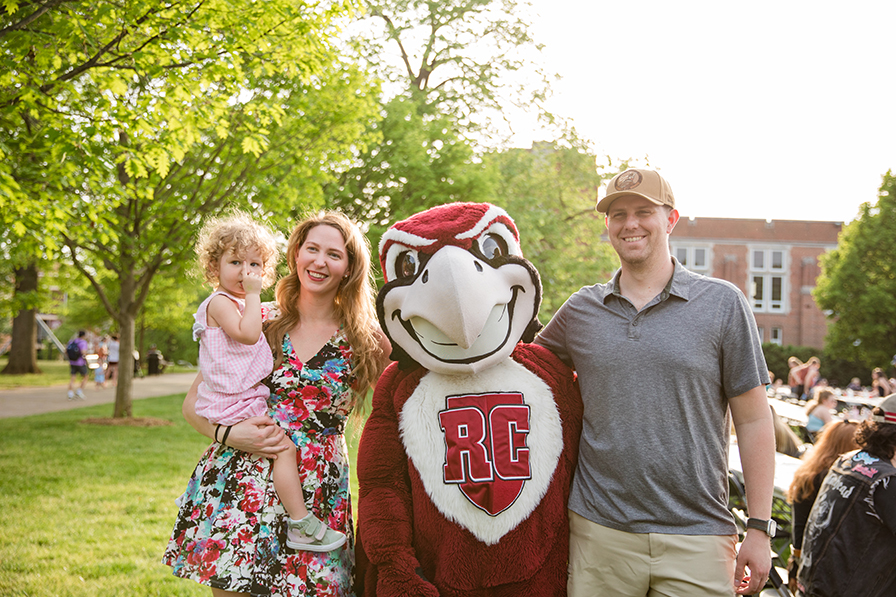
[813,171,896,368]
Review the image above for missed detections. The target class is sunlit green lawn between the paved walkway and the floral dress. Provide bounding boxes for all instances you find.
[0,394,359,597]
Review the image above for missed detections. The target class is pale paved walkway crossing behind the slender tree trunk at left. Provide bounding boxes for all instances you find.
[0,373,196,419]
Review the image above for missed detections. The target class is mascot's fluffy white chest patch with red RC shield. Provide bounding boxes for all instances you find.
[399,359,563,545]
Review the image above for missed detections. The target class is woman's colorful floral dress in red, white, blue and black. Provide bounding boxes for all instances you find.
[163,330,355,597]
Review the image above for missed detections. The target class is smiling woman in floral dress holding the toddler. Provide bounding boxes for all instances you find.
[164,212,390,597]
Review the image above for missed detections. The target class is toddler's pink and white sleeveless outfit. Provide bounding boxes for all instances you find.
[193,290,274,425]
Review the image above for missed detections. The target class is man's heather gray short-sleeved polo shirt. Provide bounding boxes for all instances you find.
[536,258,769,535]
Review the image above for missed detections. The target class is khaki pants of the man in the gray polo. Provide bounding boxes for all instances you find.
[568,511,737,597]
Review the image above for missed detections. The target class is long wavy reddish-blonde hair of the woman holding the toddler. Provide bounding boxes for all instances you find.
[264,211,382,407]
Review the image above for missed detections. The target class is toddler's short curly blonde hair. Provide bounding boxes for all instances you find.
[196,211,280,288]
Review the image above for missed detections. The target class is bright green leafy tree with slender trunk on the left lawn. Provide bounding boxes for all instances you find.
[0,0,371,416]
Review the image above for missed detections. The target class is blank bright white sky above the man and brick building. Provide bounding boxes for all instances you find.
[521,0,896,222]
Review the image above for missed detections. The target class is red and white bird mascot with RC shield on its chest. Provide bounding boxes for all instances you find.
[358,203,582,597]
